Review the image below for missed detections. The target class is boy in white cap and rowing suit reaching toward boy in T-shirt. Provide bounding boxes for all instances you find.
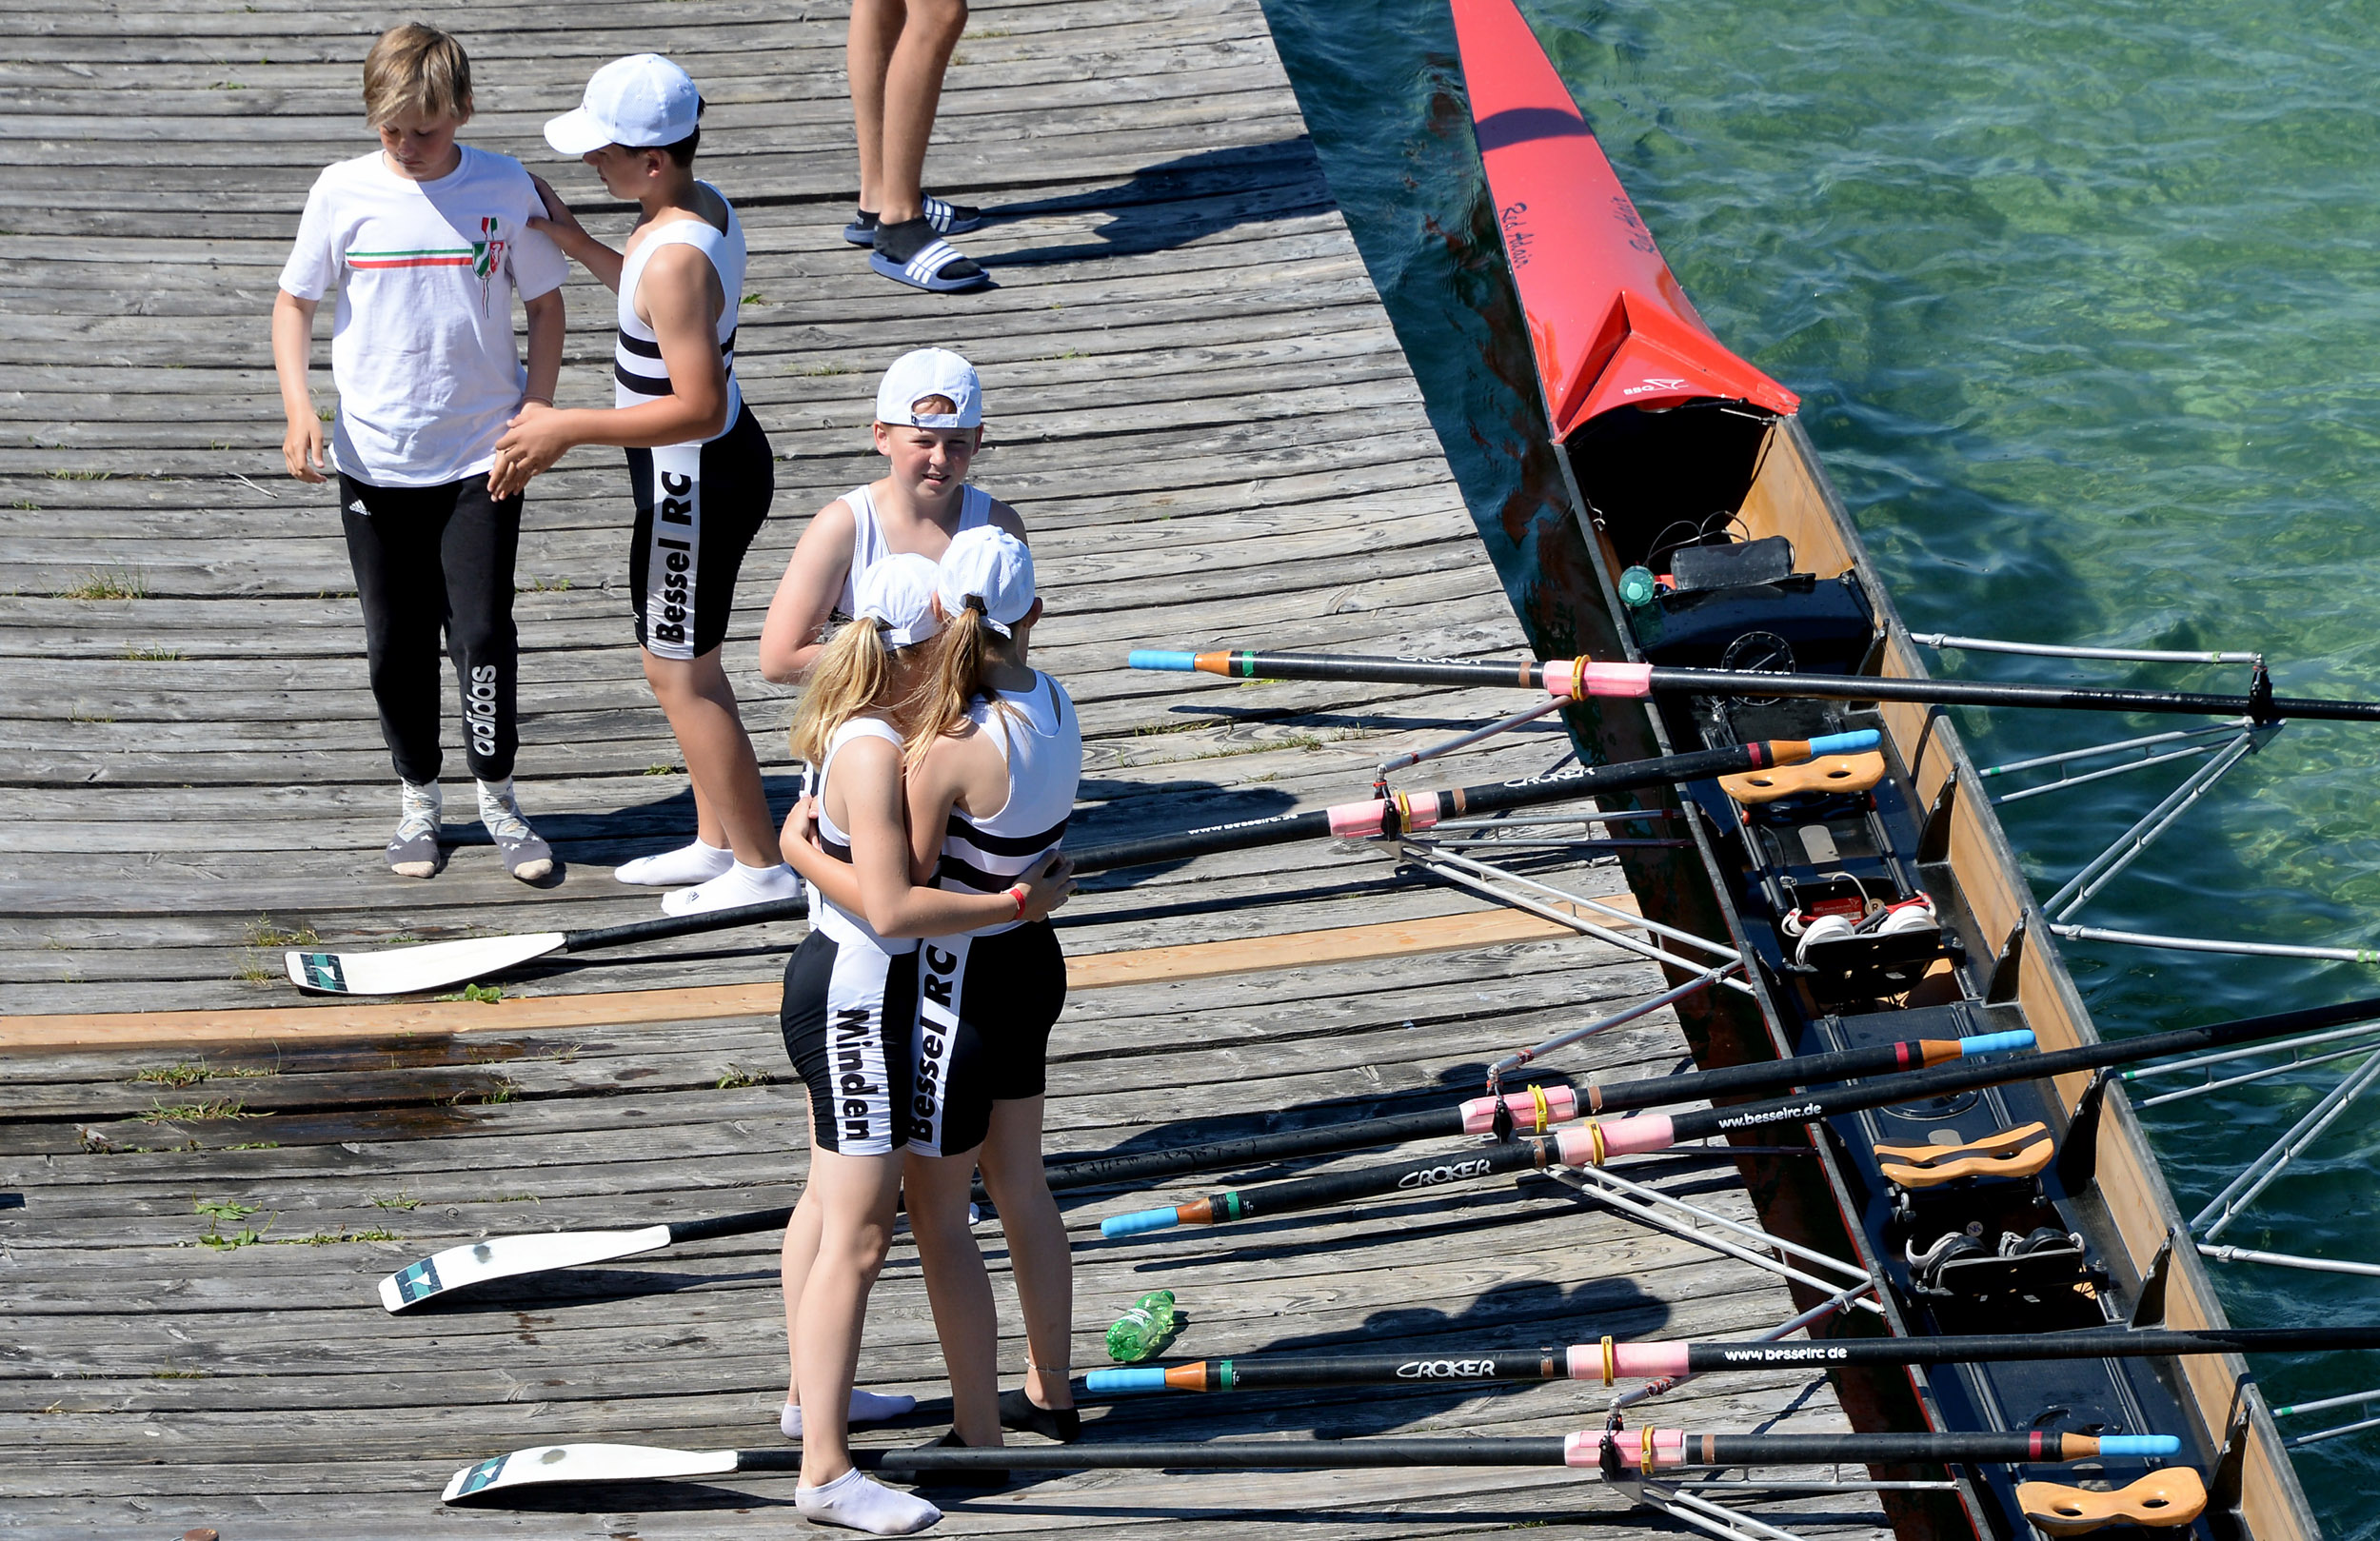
[495,54,800,916]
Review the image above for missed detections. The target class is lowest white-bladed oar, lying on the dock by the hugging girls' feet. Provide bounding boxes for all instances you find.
[443,1427,2183,1503]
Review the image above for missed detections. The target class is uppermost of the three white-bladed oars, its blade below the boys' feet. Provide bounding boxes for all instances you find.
[286,730,1878,994]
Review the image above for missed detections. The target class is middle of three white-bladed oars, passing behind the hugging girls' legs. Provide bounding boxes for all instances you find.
[381,1032,2033,1313]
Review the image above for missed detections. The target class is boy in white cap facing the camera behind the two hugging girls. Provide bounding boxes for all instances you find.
[760,347,1026,685]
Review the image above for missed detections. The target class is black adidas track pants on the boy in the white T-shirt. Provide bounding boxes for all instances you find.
[338,476,522,784]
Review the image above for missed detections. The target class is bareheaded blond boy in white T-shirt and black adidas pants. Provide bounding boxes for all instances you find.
[274,21,569,882]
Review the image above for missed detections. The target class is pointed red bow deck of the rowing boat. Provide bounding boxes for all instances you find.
[1455,0,1802,445]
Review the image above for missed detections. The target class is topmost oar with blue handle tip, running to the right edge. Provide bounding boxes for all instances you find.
[1131,652,2380,723]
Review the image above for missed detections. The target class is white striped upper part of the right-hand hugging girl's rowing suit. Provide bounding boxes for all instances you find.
[933,673,1083,937]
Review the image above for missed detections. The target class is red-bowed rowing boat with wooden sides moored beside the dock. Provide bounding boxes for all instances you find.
[1455,0,2318,1541]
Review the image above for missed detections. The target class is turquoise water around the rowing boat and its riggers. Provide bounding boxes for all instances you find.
[1269,0,2380,1512]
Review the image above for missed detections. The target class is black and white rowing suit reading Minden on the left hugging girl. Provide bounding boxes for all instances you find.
[779,719,917,1156]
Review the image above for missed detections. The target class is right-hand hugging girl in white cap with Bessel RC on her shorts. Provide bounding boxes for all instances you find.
[785,528,1083,1446]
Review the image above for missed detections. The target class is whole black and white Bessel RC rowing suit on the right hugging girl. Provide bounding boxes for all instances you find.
[909,676,1083,1156]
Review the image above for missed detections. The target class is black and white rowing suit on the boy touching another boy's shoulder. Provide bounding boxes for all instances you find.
[612,183,776,659]
